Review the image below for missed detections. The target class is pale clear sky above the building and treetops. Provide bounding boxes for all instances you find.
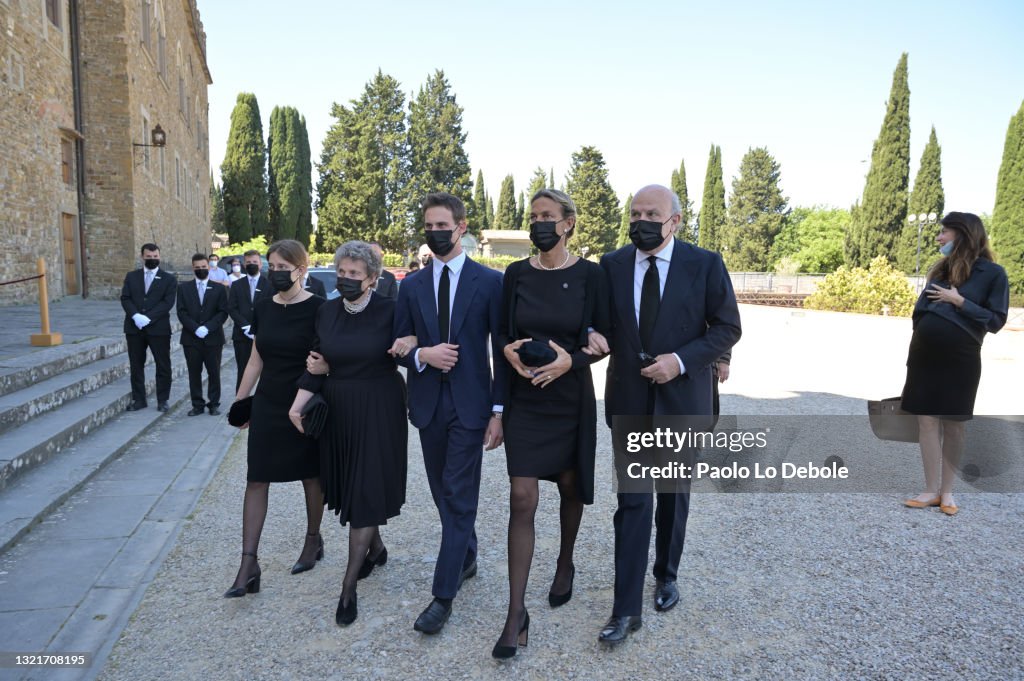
[200,0,1024,213]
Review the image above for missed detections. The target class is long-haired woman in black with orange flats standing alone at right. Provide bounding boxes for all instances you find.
[903,213,1010,515]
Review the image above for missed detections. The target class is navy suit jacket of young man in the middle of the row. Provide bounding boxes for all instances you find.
[394,257,509,429]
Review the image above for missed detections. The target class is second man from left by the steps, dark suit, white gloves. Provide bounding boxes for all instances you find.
[177,253,227,416]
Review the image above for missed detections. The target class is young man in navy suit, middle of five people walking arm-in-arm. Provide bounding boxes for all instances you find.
[391,193,508,634]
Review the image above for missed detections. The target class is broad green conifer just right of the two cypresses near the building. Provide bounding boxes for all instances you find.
[316,71,413,252]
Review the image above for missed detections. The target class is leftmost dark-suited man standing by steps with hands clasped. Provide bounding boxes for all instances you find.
[121,244,178,412]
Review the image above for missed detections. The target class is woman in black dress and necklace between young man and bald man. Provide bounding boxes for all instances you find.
[492,189,609,658]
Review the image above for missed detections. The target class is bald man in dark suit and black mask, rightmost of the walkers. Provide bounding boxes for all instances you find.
[589,185,740,644]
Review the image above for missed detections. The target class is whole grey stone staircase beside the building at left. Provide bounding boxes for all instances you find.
[0,320,234,553]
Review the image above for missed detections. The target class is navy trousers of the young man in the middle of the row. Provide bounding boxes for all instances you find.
[420,383,486,598]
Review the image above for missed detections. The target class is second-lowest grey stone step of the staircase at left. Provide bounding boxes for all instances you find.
[0,343,234,491]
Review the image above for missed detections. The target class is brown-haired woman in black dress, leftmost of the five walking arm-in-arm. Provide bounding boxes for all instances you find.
[224,240,324,598]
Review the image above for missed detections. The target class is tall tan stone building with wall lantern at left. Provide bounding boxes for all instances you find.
[0,0,212,305]
